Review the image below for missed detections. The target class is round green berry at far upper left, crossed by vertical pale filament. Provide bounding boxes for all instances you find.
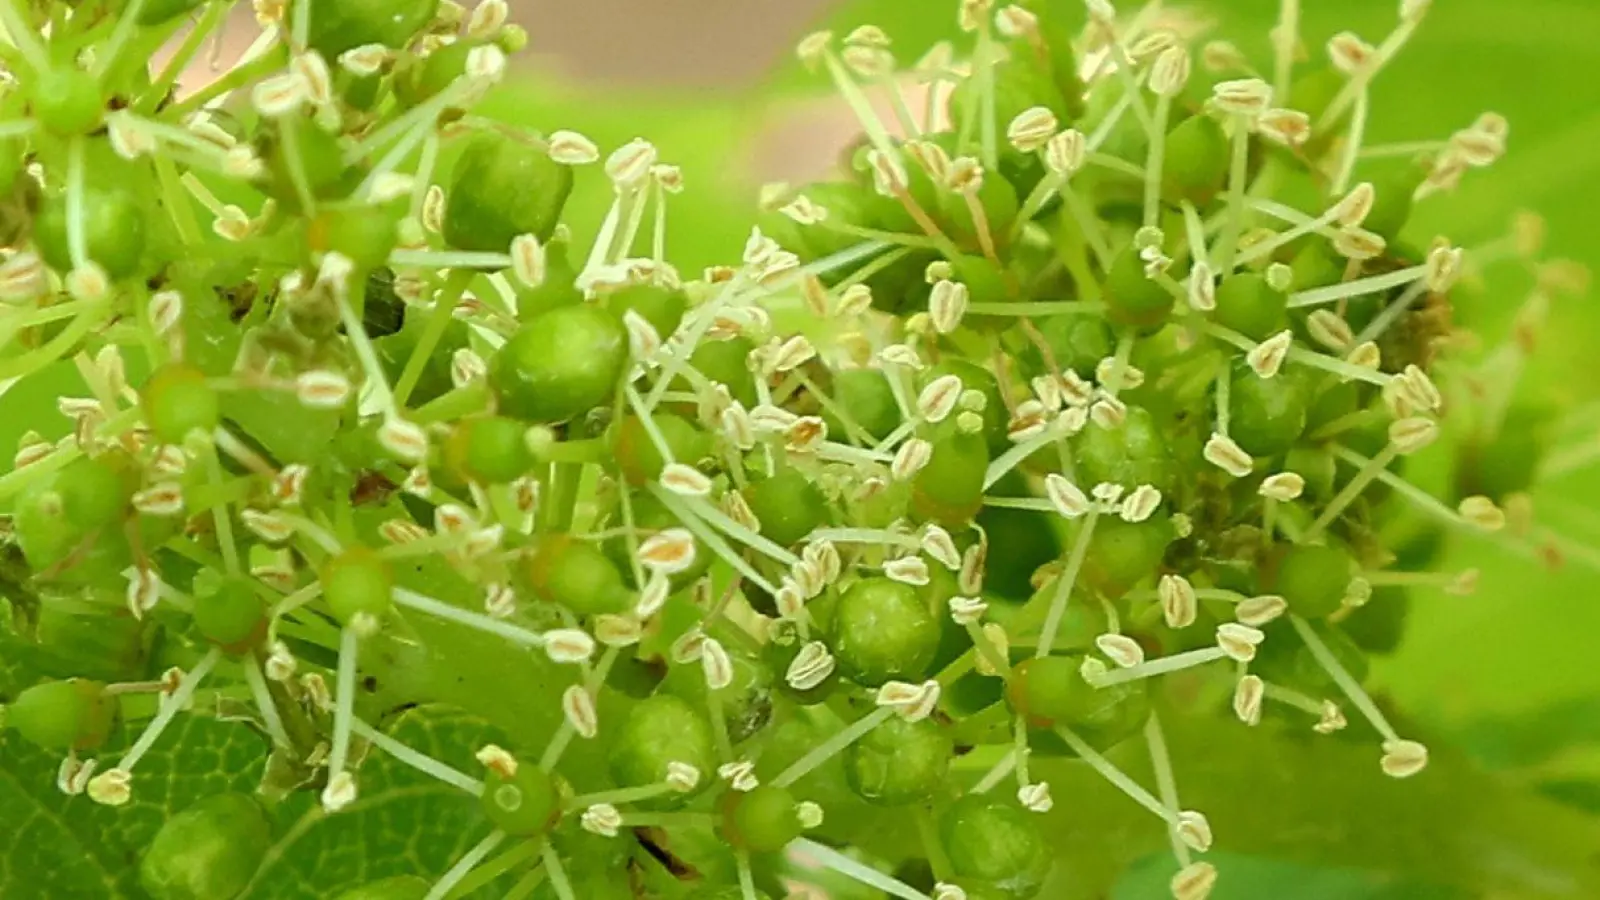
[34,179,147,280]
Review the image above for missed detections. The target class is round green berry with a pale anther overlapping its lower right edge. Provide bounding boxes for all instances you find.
[610,693,717,794]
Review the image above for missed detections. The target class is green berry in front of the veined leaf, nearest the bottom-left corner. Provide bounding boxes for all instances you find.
[139,794,272,900]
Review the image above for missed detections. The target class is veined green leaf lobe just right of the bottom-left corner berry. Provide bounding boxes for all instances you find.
[238,706,510,900]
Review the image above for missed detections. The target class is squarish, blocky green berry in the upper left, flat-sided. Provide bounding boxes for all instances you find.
[445,133,573,253]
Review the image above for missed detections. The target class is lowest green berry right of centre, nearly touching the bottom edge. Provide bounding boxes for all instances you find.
[939,794,1051,900]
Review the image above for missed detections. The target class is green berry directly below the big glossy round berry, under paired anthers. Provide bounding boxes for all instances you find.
[845,716,955,806]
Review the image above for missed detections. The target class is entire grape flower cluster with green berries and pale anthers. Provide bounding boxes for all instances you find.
[0,0,1592,900]
